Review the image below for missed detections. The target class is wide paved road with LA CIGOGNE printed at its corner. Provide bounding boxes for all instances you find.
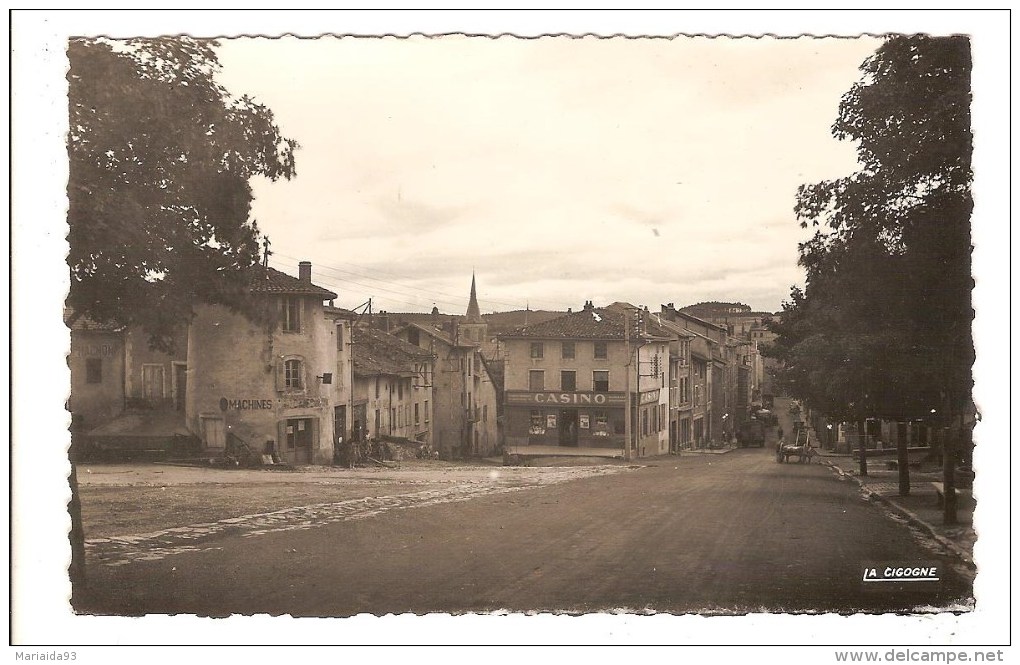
[78,448,971,616]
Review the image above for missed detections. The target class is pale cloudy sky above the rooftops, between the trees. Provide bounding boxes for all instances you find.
[218,36,880,313]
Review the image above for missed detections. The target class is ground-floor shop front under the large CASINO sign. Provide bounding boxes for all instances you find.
[505,391,626,448]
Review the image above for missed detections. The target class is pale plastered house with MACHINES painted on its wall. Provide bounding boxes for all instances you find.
[186,261,340,464]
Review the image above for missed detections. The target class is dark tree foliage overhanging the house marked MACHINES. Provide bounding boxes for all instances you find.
[67,38,297,349]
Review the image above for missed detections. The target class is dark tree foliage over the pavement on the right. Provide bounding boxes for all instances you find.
[771,36,973,419]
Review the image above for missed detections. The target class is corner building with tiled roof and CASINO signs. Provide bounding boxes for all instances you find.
[500,302,669,456]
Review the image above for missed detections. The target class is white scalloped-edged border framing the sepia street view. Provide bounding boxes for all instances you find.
[9,10,1012,663]
